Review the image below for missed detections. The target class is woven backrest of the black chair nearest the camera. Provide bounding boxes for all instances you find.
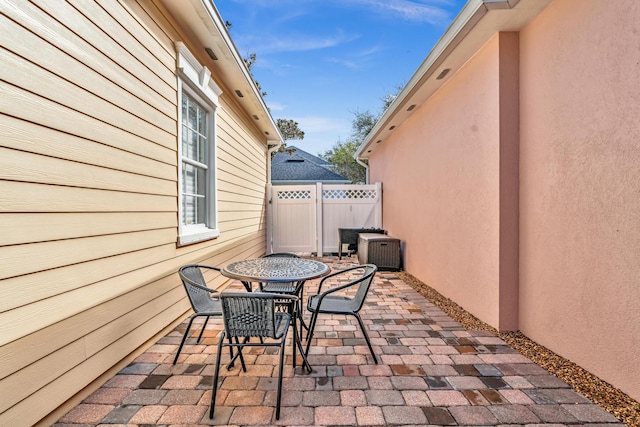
[220,292,279,338]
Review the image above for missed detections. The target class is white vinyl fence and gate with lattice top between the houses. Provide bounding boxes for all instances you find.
[267,183,382,255]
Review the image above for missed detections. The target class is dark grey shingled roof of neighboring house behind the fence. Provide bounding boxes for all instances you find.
[271,146,351,185]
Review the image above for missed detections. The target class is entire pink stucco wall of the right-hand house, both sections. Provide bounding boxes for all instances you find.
[369,0,640,399]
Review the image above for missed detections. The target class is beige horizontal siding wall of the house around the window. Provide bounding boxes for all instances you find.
[0,0,267,425]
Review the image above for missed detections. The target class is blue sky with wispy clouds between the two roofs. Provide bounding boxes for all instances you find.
[215,0,466,155]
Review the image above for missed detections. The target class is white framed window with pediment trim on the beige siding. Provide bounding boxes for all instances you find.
[176,42,222,245]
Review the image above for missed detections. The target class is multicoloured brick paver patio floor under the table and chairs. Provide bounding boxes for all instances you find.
[54,257,623,427]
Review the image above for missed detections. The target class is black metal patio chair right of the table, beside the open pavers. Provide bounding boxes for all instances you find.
[305,264,378,364]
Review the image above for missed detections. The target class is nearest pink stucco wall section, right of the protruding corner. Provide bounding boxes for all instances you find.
[520,0,640,399]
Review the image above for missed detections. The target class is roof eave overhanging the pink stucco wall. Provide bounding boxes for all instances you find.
[354,0,553,160]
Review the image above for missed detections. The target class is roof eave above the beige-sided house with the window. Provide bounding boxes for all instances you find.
[159,0,283,144]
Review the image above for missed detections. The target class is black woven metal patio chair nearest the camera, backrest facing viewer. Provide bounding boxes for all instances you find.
[209,292,311,419]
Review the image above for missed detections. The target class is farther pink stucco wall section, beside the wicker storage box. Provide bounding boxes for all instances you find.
[369,38,510,326]
